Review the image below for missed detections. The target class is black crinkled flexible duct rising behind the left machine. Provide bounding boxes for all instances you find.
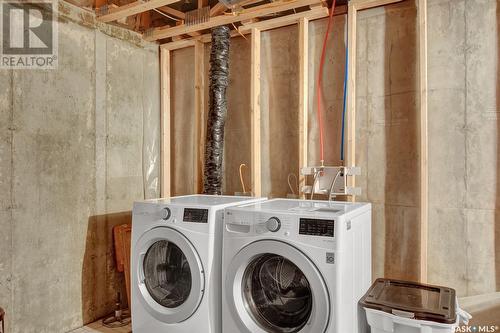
[203,26,231,194]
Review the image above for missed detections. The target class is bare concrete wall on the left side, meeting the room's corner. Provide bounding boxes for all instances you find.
[0,3,160,333]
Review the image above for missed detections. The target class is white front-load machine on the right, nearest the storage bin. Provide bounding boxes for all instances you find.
[222,199,371,333]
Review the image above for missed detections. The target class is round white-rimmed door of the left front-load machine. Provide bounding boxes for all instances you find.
[137,227,205,324]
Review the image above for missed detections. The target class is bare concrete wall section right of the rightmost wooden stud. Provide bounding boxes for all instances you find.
[429,0,500,296]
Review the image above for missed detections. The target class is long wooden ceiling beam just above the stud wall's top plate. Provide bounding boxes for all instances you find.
[144,0,320,41]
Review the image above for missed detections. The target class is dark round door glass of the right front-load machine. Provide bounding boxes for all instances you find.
[242,253,313,333]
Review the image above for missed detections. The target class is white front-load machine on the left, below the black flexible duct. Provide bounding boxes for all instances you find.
[131,195,263,333]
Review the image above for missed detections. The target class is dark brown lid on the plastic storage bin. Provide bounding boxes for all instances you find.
[359,279,457,324]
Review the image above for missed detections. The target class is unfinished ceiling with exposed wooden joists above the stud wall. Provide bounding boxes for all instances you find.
[69,0,347,43]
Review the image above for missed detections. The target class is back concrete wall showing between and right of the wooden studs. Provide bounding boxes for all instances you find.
[169,0,500,296]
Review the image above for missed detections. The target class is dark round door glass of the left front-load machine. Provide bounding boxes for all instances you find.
[144,240,191,308]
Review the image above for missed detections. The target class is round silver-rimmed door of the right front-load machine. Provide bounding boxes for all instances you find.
[226,240,330,333]
